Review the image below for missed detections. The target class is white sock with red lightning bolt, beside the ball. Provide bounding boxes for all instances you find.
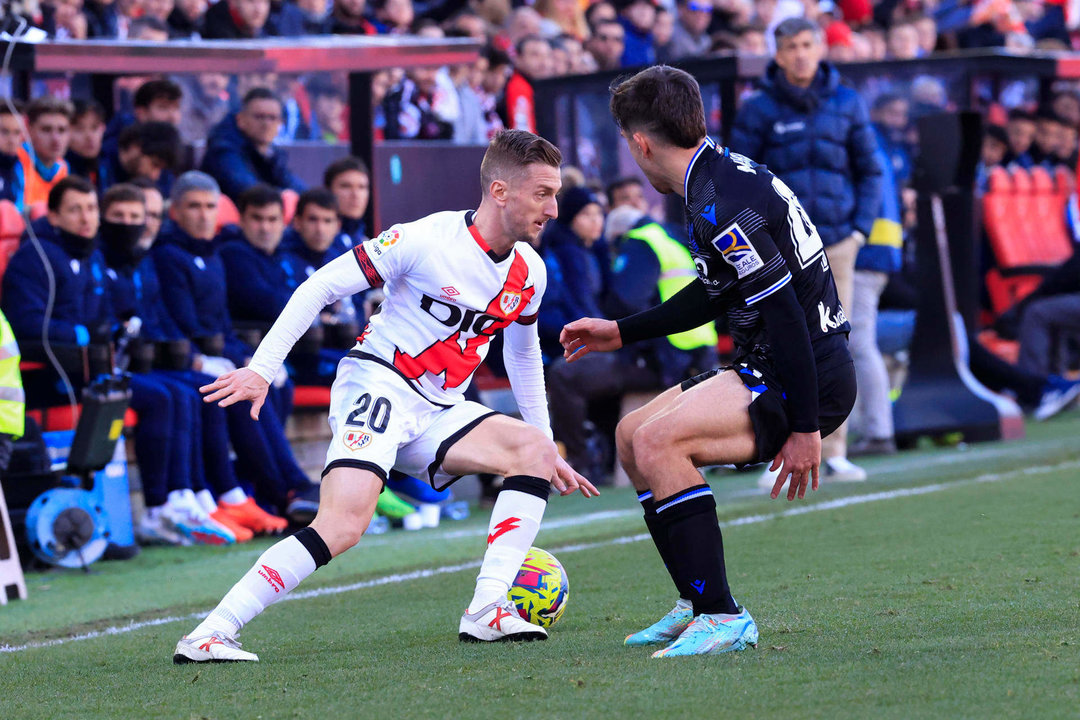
[469,488,548,612]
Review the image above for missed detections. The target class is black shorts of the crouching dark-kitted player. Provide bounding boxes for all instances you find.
[681,354,855,465]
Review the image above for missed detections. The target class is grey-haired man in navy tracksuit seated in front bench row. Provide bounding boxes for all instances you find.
[151,172,319,524]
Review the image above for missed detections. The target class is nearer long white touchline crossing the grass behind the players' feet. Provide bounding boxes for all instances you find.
[0,460,1080,653]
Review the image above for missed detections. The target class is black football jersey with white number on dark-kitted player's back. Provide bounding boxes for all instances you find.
[685,139,851,352]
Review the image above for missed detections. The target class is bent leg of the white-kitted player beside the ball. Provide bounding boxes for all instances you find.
[433,414,557,641]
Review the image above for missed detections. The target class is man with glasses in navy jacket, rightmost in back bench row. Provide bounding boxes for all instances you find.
[202,87,305,198]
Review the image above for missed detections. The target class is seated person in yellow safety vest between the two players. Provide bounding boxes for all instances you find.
[548,206,718,483]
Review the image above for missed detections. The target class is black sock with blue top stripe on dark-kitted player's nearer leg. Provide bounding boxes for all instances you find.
[656,485,739,615]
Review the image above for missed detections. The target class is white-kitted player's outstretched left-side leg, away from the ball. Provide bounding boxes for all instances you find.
[173,466,382,663]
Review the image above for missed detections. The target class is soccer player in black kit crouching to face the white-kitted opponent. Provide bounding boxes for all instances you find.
[562,66,855,657]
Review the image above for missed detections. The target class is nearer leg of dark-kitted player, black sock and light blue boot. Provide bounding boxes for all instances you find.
[631,371,765,656]
